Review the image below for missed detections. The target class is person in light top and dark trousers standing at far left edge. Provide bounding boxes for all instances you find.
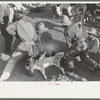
[0,4,12,53]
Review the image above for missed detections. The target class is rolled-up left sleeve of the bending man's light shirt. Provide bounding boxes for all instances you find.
[6,22,17,35]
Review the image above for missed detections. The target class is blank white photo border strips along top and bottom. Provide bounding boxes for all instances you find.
[0,1,100,99]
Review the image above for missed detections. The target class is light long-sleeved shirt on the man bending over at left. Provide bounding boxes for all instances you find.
[6,19,37,42]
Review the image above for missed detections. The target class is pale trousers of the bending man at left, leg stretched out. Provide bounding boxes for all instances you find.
[1,42,33,80]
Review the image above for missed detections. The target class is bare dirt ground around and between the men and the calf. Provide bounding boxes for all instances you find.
[0,12,100,81]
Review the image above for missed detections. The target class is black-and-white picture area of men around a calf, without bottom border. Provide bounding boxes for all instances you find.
[0,1,100,97]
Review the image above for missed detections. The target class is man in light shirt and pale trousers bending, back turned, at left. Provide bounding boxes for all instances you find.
[0,14,37,81]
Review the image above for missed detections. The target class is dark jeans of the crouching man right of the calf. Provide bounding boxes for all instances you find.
[66,48,98,69]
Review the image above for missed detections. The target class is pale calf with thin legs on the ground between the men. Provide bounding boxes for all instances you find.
[25,52,65,80]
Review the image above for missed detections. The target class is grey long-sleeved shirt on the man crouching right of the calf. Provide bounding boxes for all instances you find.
[64,24,86,48]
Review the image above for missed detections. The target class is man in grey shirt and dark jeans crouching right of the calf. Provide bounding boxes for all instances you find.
[61,21,100,72]
